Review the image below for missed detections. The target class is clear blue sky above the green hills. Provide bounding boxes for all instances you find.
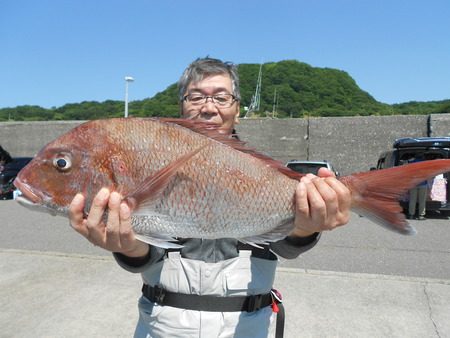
[0,0,450,108]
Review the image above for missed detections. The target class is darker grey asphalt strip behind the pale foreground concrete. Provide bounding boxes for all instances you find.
[0,201,450,280]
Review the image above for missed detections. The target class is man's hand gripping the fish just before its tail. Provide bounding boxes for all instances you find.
[290,168,351,237]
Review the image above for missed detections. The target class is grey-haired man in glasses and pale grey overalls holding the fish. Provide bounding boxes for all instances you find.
[70,58,350,338]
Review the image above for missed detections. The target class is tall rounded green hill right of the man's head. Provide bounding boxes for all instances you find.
[239,60,390,117]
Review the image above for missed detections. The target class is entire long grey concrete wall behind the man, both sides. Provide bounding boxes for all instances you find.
[0,114,450,175]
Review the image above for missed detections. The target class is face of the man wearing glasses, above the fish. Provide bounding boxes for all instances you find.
[181,74,240,134]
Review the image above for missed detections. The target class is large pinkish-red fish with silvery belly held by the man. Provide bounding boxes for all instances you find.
[15,118,450,246]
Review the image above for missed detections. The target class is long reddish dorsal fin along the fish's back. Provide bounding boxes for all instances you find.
[156,118,304,180]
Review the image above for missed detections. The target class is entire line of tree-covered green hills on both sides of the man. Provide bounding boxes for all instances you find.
[0,60,450,121]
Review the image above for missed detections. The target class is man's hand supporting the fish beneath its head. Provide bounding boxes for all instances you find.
[69,188,149,257]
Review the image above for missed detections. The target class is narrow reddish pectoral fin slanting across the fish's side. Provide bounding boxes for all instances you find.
[124,145,206,213]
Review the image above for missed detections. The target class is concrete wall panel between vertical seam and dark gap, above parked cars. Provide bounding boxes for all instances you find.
[308,116,427,175]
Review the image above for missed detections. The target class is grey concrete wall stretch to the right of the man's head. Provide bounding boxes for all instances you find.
[237,115,430,175]
